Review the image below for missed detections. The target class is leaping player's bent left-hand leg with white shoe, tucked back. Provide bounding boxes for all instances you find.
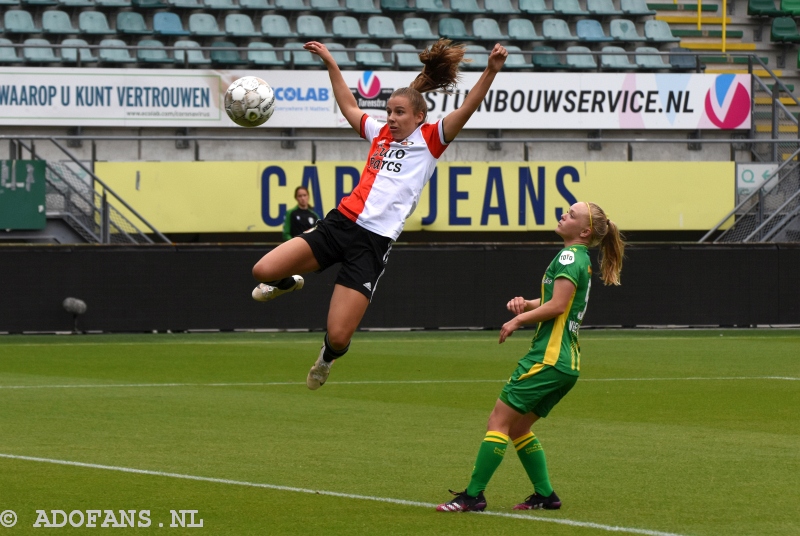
[252,237,319,302]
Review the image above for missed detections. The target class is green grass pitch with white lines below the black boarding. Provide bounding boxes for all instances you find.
[0,330,800,536]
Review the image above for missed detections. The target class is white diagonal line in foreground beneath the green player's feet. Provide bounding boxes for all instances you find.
[0,453,681,536]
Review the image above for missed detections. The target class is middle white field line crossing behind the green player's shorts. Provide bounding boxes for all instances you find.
[0,376,800,389]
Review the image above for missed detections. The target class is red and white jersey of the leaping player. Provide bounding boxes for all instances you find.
[339,114,447,240]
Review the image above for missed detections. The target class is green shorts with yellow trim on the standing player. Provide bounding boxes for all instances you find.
[500,361,578,417]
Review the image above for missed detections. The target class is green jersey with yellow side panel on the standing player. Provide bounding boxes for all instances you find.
[519,245,592,379]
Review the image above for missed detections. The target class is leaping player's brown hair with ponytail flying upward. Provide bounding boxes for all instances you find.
[390,39,466,122]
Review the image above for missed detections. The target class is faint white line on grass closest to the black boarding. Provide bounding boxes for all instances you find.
[0,331,800,348]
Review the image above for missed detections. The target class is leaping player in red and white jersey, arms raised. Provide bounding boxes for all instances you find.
[253,39,508,389]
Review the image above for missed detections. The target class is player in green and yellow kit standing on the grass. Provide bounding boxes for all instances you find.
[436,202,625,512]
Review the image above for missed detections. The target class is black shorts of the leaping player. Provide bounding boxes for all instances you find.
[299,209,393,301]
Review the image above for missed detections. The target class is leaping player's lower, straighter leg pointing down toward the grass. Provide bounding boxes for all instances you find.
[306,284,369,390]
